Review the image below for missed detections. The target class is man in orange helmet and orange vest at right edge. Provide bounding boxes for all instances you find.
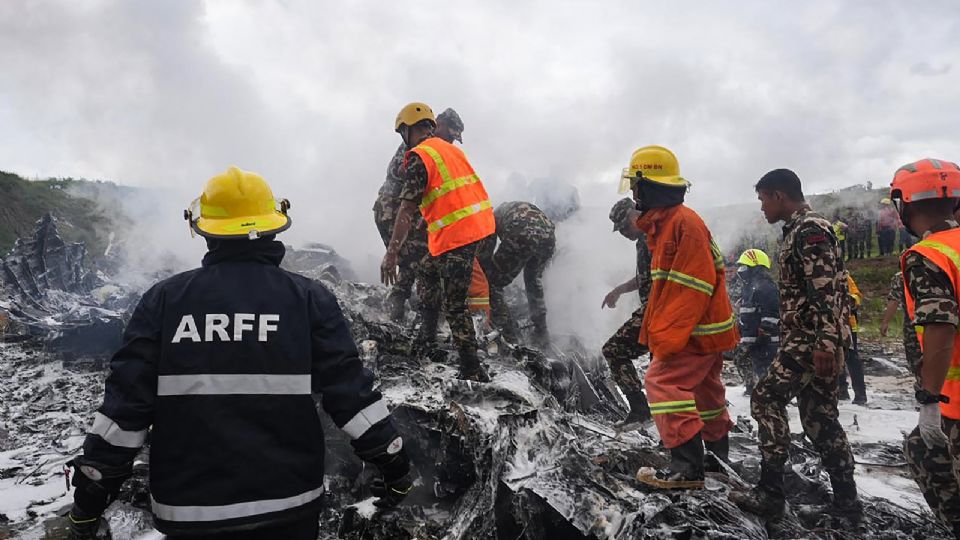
[881,160,960,538]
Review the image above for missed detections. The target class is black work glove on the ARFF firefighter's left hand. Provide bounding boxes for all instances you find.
[67,456,132,520]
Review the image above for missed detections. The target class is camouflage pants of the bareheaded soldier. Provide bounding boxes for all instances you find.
[750,350,854,482]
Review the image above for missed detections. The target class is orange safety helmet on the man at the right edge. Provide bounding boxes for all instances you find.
[890,158,960,215]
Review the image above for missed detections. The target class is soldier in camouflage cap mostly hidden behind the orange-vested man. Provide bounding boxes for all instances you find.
[373,109,463,321]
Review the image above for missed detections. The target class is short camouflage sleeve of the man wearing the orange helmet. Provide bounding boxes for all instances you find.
[903,222,960,326]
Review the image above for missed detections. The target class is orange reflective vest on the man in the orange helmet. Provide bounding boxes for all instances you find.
[900,229,960,420]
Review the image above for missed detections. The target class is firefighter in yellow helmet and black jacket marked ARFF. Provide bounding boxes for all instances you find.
[69,167,412,540]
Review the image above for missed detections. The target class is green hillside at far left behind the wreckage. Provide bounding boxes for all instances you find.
[0,171,111,257]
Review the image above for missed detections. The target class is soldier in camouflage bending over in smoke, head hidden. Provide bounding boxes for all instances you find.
[477,201,557,347]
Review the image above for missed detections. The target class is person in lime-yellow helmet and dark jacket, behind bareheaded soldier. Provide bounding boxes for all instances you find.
[736,249,780,394]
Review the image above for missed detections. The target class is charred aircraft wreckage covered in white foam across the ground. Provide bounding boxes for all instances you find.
[0,216,949,540]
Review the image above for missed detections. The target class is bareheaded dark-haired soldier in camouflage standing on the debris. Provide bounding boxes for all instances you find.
[730,169,862,524]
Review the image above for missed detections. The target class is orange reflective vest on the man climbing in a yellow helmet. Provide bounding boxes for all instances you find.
[410,137,496,257]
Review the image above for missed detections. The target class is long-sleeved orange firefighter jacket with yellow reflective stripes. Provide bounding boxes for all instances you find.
[637,204,740,358]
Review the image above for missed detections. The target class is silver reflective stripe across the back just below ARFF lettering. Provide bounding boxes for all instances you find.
[157,373,310,396]
